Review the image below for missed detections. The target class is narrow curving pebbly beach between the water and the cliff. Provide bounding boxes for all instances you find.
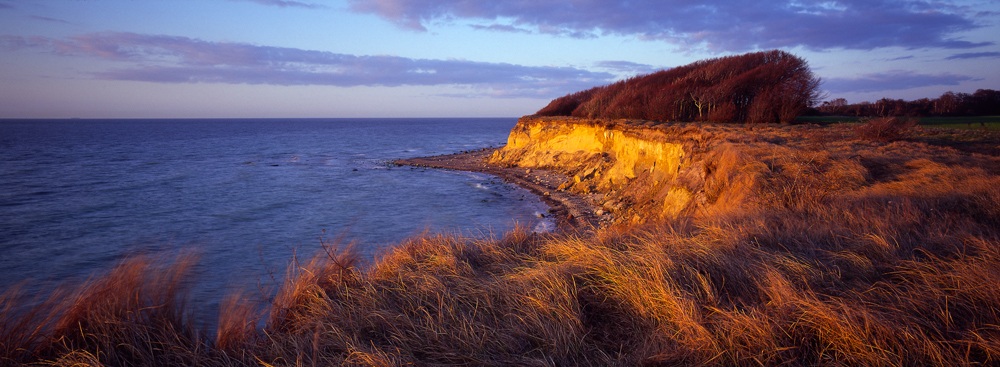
[393,148,609,232]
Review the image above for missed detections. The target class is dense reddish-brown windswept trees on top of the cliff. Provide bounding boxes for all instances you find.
[536,50,820,123]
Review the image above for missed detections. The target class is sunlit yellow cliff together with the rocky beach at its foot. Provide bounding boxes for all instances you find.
[394,116,718,231]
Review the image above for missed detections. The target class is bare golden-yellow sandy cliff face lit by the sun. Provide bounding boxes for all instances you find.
[490,117,736,222]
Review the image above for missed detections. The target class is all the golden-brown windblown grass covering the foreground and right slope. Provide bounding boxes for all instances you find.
[0,123,1000,366]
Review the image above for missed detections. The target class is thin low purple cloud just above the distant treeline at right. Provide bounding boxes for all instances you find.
[823,70,973,93]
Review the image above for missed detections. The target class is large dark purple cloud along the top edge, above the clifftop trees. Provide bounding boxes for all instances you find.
[348,0,993,51]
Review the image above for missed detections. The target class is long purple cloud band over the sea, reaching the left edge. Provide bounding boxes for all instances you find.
[0,32,613,98]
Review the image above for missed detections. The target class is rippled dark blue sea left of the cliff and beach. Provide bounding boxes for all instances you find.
[0,118,552,314]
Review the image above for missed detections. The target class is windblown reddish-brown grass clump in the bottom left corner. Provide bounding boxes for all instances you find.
[0,255,207,366]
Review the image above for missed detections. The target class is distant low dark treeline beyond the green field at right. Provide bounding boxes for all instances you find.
[816,89,1000,117]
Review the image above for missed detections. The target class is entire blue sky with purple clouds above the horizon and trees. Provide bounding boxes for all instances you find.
[0,0,1000,118]
